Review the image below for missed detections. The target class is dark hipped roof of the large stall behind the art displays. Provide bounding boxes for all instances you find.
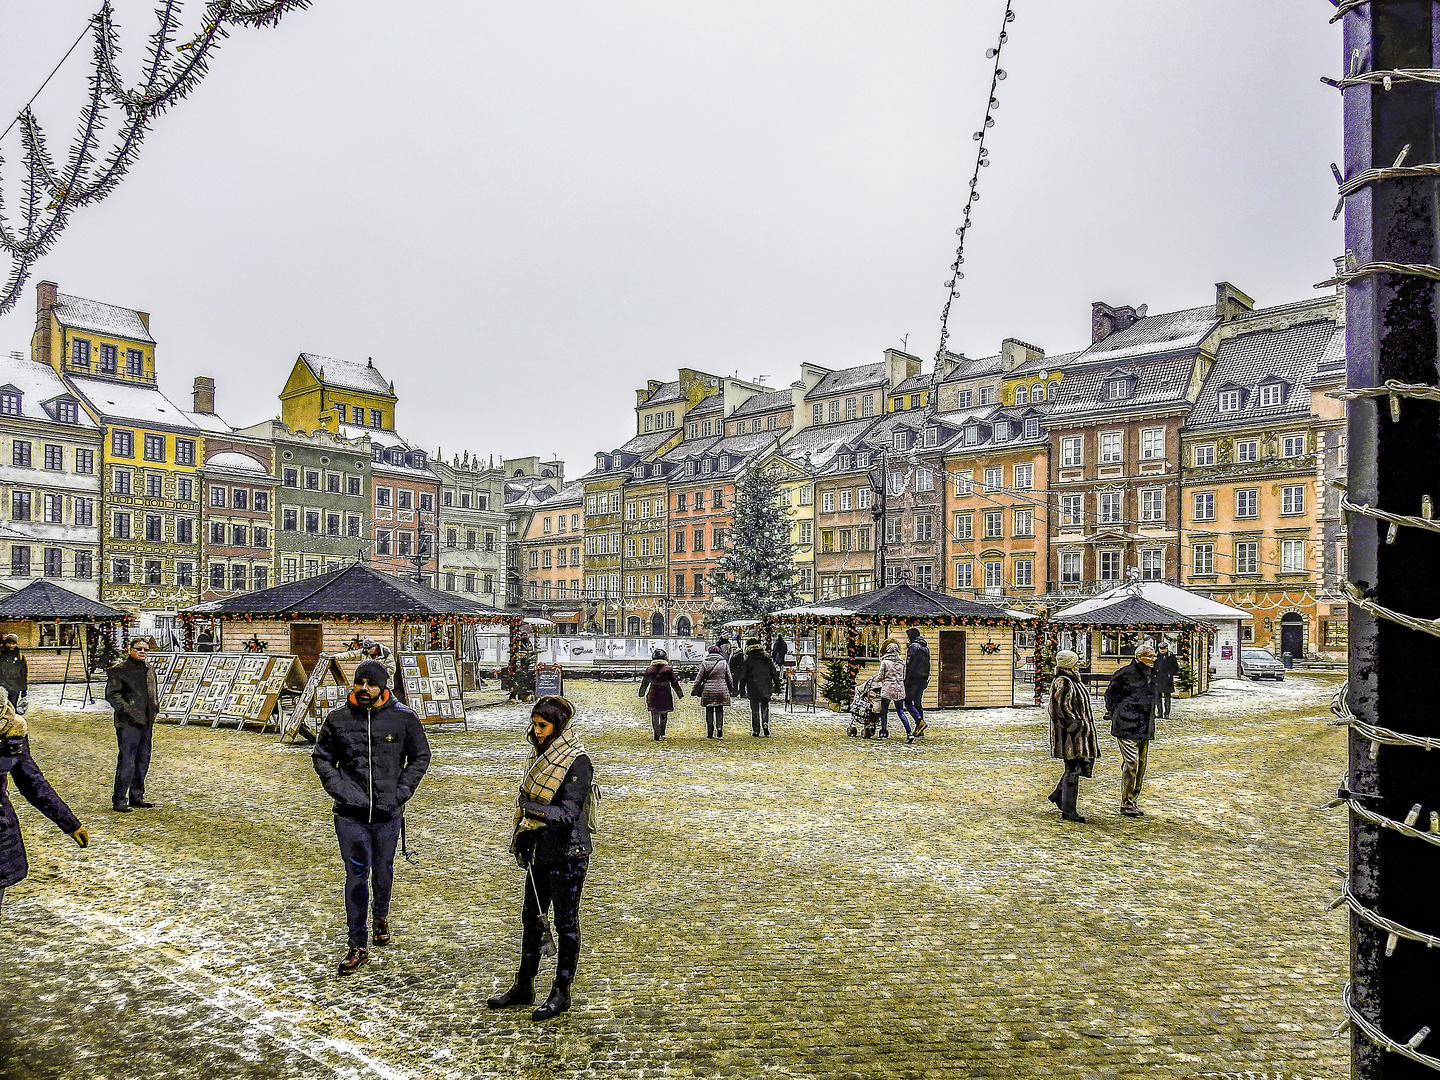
[186,563,516,619]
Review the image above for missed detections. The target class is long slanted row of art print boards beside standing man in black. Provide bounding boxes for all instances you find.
[154,652,305,732]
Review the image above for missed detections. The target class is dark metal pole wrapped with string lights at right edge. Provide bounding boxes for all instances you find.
[1325,0,1440,1080]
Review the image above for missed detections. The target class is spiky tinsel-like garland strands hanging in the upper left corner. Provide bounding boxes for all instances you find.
[0,0,311,314]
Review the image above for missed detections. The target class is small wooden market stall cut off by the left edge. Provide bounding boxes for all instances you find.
[0,577,134,694]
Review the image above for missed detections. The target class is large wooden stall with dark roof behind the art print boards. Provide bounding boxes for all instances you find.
[180,563,526,723]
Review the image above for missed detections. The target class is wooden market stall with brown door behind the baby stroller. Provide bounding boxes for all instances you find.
[765,583,1028,708]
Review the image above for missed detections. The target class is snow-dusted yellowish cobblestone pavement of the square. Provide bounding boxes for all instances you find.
[0,675,1346,1080]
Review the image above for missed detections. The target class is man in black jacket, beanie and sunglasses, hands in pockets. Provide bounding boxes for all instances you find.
[311,660,431,975]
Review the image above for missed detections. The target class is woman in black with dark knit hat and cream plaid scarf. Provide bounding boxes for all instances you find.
[485,697,595,1020]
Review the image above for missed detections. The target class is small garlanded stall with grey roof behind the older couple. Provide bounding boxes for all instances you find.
[1035,593,1215,703]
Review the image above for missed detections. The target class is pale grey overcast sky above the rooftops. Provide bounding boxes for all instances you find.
[0,0,1342,475]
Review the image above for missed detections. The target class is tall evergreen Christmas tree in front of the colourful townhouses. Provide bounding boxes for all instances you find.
[707,469,799,625]
